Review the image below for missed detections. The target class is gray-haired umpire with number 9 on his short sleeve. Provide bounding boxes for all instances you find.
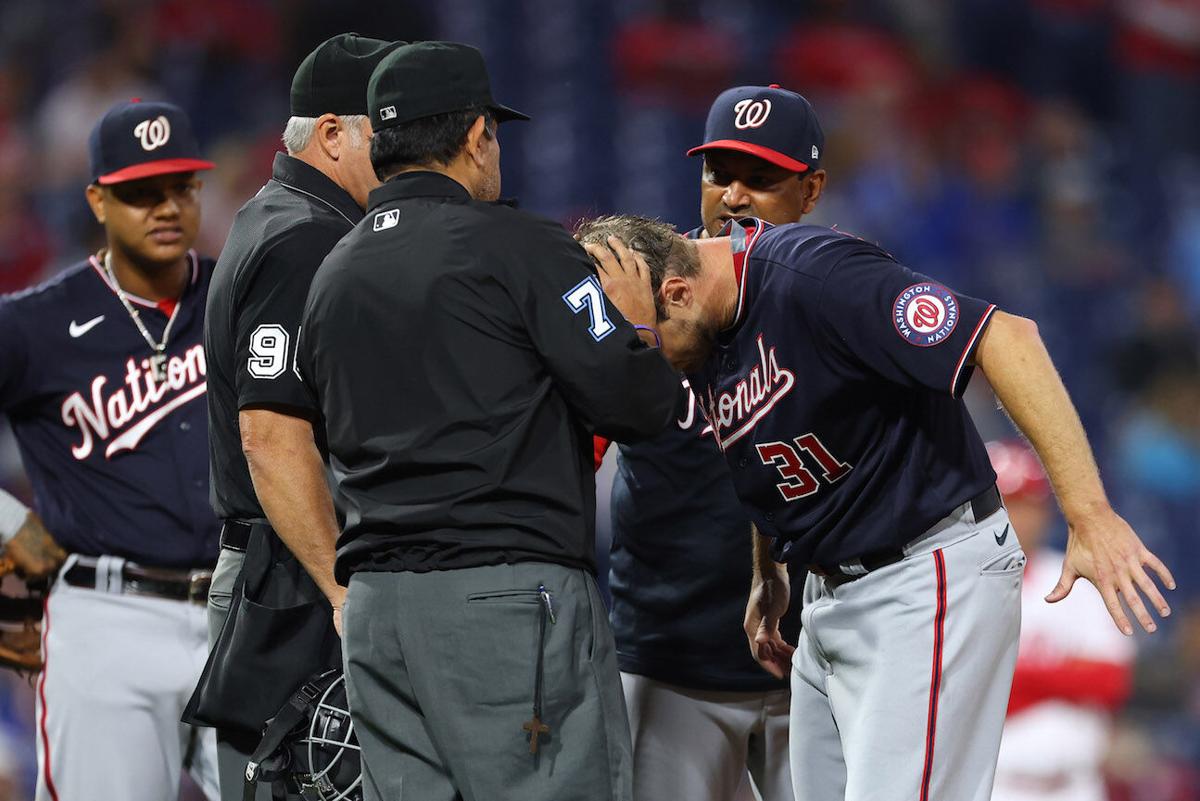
[202,34,400,801]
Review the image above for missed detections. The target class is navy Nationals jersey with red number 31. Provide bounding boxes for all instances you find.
[689,219,996,570]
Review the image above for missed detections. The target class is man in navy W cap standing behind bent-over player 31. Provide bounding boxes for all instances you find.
[600,85,826,801]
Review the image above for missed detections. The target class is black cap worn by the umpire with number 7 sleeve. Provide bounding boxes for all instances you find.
[367,42,529,131]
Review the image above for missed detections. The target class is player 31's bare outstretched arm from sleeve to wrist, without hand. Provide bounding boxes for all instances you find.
[976,312,1109,523]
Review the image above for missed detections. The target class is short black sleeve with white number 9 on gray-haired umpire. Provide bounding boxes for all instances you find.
[234,227,341,415]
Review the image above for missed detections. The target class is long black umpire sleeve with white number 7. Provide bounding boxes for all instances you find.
[511,222,680,441]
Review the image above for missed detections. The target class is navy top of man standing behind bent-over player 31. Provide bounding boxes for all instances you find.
[610,381,799,692]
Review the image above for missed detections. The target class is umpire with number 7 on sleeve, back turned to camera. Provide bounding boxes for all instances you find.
[299,42,679,801]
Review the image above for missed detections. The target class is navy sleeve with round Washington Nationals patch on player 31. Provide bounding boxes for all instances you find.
[818,236,996,397]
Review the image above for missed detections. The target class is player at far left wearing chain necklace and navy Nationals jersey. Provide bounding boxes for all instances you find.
[0,102,217,801]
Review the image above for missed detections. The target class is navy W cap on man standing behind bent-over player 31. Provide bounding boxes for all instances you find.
[688,84,824,173]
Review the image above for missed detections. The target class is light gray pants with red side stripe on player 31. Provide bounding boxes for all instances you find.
[791,505,1025,801]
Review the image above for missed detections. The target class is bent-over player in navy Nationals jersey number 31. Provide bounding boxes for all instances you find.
[580,216,1174,801]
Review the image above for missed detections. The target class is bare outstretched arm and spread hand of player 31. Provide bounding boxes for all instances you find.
[976,312,1175,634]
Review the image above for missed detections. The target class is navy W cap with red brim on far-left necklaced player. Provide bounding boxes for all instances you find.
[88,100,216,186]
